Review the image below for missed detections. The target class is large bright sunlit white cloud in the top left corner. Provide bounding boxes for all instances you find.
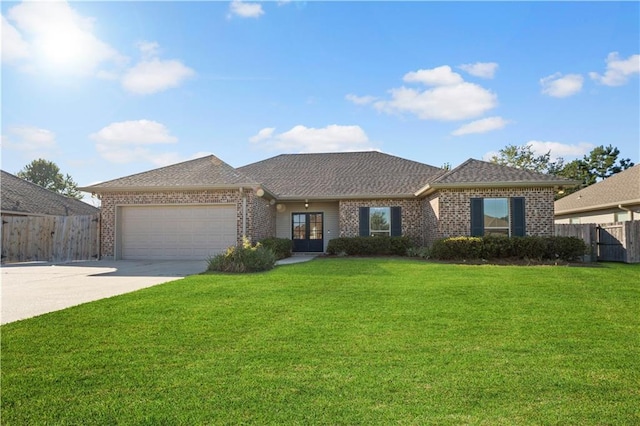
[3,1,126,75]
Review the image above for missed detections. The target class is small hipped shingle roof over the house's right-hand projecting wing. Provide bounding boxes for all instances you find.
[415,159,578,195]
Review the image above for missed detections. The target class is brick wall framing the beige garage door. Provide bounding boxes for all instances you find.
[100,189,251,258]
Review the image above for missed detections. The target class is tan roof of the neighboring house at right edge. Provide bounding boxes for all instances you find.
[555,164,640,215]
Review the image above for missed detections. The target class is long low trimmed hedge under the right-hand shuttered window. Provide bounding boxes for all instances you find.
[431,235,588,261]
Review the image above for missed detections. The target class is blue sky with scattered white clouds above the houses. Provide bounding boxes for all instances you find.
[1,1,640,205]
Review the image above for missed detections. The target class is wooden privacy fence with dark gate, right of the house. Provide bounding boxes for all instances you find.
[555,220,640,263]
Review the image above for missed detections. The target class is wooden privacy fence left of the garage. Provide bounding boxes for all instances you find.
[1,214,100,262]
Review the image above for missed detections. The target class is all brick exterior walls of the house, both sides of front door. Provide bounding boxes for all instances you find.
[100,188,554,258]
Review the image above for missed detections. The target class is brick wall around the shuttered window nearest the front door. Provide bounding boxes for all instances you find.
[338,199,423,245]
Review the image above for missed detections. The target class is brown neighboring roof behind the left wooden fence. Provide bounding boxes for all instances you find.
[0,170,99,216]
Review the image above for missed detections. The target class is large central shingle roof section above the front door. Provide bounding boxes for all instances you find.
[238,151,443,199]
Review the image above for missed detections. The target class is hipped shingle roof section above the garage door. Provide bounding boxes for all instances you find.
[81,155,258,192]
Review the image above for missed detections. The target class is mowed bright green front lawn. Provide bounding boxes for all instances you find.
[1,258,640,425]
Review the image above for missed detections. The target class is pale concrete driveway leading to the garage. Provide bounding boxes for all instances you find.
[0,260,207,324]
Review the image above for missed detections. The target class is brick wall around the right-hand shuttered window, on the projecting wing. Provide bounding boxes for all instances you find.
[422,188,554,245]
